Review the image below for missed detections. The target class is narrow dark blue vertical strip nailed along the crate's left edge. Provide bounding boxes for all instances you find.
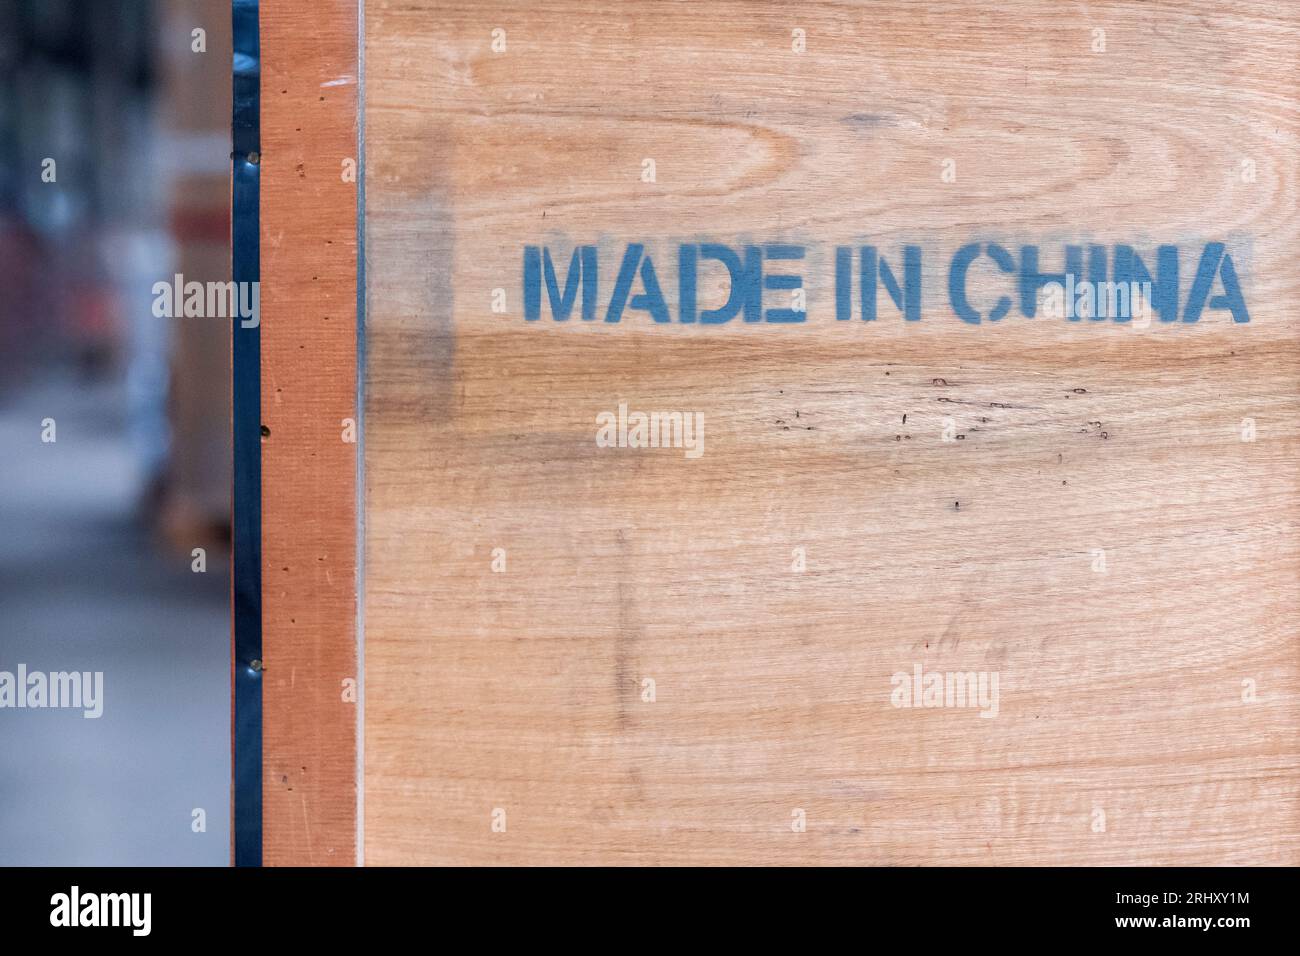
[230,0,261,866]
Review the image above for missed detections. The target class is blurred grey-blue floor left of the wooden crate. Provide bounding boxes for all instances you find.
[0,377,230,866]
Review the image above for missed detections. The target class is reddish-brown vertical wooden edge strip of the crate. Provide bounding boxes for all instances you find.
[261,0,358,866]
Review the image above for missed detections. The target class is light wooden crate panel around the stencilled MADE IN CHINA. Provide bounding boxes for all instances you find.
[358,0,1300,864]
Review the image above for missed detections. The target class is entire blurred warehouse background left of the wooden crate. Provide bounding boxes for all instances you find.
[0,0,231,865]
